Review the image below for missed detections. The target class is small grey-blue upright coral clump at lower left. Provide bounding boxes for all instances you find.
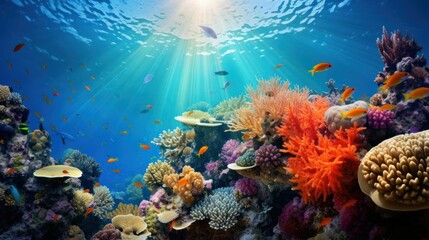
[93,186,115,219]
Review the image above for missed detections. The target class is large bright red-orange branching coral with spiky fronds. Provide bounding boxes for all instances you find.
[278,98,364,203]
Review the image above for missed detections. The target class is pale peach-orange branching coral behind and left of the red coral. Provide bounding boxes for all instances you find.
[228,78,308,142]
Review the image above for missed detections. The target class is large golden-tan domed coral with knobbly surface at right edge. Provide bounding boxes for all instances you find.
[358,130,429,211]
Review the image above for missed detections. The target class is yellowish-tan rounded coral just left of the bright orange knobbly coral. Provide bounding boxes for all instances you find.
[143,160,174,190]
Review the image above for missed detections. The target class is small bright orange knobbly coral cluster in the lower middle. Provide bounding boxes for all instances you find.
[164,166,204,205]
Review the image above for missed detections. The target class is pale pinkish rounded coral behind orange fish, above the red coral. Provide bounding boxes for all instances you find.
[325,101,369,133]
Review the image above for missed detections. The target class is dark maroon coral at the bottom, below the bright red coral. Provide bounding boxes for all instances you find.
[279,197,317,239]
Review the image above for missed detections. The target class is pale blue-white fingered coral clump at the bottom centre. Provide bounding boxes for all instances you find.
[191,187,240,230]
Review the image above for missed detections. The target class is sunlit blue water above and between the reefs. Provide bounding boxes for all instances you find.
[0,0,429,191]
